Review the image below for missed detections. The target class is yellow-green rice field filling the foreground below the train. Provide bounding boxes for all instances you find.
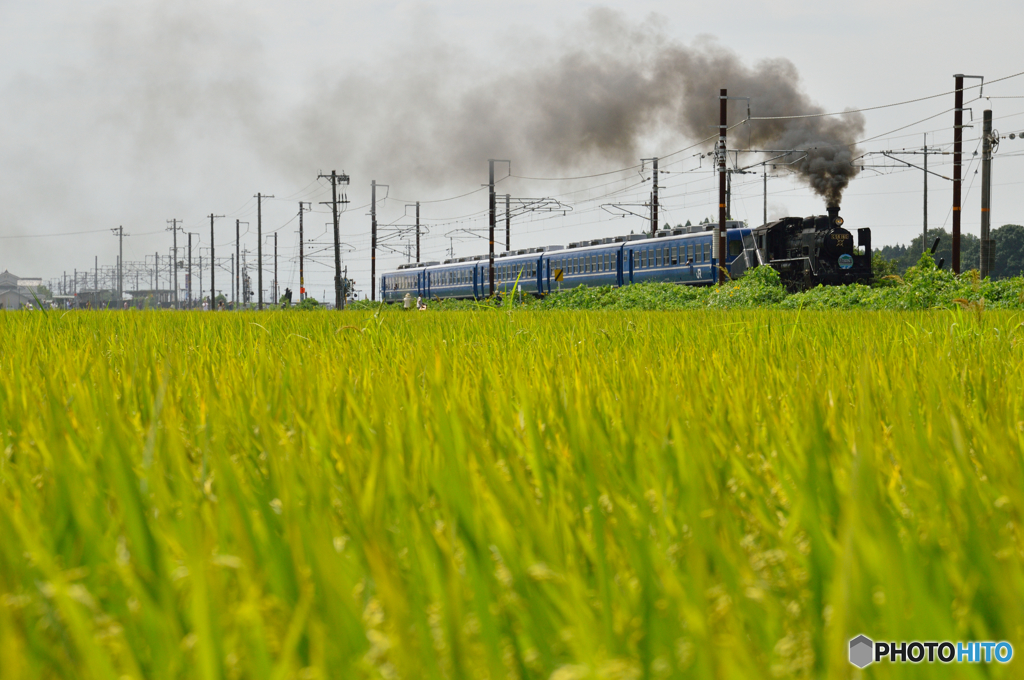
[0,310,1024,680]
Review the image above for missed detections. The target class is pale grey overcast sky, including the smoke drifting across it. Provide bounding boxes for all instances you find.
[0,0,1024,300]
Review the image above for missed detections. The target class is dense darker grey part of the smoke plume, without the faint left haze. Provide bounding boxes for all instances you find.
[285,9,864,205]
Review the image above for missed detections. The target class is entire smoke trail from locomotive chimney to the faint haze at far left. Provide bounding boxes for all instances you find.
[10,0,864,218]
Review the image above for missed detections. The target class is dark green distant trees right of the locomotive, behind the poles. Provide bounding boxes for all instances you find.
[872,224,1024,279]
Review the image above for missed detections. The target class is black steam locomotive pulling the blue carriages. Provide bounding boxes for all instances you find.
[751,207,871,290]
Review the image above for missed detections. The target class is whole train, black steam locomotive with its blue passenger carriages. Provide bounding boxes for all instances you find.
[380,208,871,302]
